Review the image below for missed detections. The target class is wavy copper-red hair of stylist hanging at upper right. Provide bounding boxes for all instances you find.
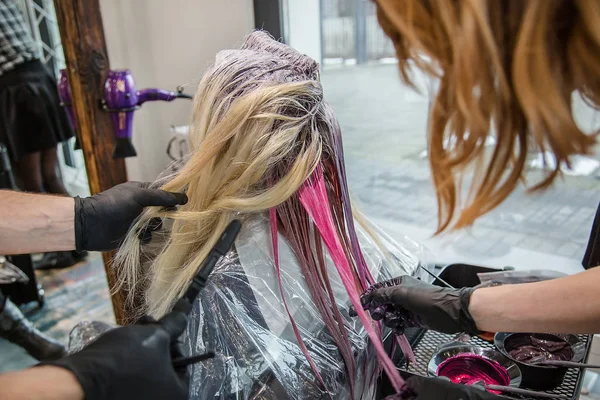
[375,0,600,231]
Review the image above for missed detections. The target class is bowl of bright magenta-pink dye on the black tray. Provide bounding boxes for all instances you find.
[427,343,521,394]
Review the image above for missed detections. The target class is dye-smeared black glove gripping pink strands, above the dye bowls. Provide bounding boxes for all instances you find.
[361,276,480,335]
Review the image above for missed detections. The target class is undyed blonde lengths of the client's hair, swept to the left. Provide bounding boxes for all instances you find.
[116,72,322,316]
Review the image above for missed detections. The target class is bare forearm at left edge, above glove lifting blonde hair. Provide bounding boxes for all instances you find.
[0,190,75,255]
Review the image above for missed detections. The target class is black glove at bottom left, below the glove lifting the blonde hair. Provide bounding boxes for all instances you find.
[40,311,189,400]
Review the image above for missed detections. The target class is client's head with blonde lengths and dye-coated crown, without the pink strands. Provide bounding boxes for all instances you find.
[117,32,339,315]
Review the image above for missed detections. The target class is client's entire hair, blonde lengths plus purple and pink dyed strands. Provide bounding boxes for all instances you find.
[116,32,401,395]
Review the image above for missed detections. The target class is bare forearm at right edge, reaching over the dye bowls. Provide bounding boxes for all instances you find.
[469,268,600,333]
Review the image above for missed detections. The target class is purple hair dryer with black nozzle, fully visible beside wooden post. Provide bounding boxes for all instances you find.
[103,69,192,158]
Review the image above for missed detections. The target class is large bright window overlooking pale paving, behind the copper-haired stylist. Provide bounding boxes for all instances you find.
[284,0,600,273]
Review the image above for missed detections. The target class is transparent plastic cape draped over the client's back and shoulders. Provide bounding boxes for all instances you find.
[69,214,422,400]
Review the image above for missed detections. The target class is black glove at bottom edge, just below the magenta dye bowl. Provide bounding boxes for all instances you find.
[386,376,509,400]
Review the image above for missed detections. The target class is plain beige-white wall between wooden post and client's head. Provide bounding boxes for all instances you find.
[100,0,254,181]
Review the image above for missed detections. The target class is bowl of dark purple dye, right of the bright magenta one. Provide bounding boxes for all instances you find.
[494,332,585,390]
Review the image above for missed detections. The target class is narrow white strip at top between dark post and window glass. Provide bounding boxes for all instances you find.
[286,0,321,62]
